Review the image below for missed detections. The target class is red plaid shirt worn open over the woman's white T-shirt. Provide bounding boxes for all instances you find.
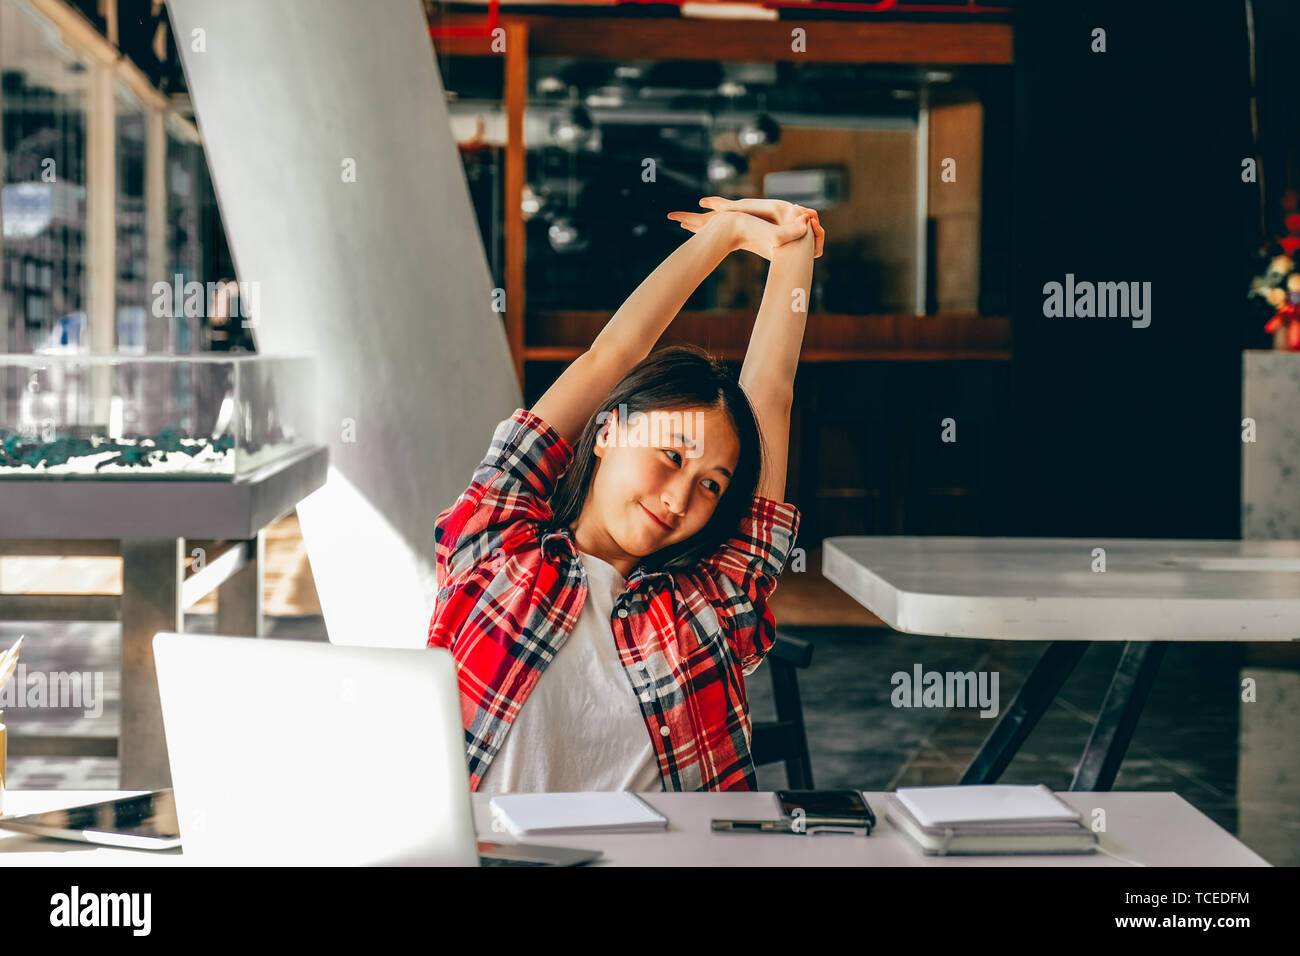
[429,408,800,791]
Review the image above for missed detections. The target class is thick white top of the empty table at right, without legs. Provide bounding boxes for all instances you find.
[822,536,1300,641]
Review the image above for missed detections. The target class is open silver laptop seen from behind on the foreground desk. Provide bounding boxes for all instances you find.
[153,632,601,866]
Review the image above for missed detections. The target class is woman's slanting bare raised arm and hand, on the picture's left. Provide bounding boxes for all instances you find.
[532,212,807,445]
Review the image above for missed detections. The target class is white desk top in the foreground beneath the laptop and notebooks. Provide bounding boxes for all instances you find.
[0,790,1268,868]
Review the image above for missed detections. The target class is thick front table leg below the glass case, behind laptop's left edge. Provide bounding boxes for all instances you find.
[117,537,185,790]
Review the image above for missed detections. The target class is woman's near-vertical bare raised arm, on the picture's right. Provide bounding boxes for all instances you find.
[740,229,816,501]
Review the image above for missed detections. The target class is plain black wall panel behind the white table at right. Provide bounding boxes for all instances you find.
[998,1,1258,538]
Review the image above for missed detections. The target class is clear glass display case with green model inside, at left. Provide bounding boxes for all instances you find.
[0,354,317,481]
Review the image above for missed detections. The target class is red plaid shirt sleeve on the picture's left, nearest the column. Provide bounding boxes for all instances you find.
[433,408,573,594]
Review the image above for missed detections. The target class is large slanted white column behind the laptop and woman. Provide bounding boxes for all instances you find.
[168,0,520,646]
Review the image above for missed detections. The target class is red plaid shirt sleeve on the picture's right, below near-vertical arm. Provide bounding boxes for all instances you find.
[701,496,800,676]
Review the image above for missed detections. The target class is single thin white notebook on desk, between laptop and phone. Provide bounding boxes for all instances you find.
[489,790,668,836]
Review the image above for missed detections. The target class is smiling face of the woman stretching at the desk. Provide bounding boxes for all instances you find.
[573,408,740,576]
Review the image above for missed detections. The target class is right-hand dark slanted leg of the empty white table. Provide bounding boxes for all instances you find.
[1070,641,1167,791]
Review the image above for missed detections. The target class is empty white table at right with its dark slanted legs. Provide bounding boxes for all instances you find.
[822,536,1300,791]
